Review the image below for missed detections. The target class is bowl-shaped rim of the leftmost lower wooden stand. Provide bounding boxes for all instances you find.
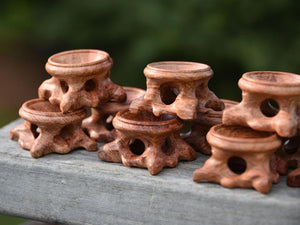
[19,99,86,125]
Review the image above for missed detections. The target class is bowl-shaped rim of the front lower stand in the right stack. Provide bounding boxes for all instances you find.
[207,124,281,152]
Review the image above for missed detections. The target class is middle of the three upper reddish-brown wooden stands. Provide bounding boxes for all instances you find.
[130,61,224,120]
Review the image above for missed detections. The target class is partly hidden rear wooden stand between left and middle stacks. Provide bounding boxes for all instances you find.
[82,87,145,142]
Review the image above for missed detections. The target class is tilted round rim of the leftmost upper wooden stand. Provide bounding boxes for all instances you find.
[46,49,112,77]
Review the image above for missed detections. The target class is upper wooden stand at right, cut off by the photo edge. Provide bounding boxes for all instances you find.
[223,71,300,137]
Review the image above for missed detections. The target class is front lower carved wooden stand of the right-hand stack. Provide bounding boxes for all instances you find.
[193,125,281,194]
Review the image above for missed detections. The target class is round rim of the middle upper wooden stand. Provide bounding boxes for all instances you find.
[144,61,213,81]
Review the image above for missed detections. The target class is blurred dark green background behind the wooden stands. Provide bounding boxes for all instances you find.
[0,0,300,224]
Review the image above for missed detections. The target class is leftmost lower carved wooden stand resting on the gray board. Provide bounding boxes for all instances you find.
[10,99,97,158]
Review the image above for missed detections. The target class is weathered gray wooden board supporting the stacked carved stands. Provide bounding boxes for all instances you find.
[0,120,300,225]
